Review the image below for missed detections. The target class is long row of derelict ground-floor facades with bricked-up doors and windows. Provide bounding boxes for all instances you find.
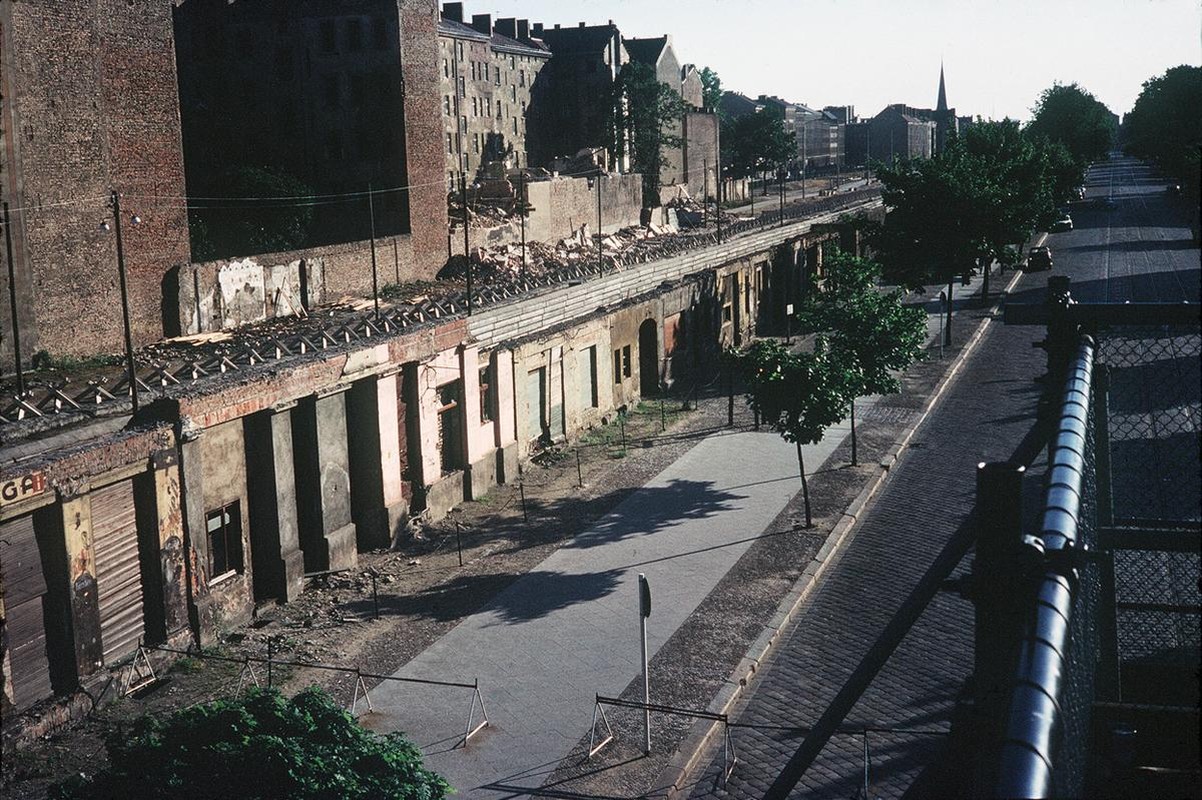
[0,188,879,732]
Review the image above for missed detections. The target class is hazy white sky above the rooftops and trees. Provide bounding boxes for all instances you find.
[473,0,1202,119]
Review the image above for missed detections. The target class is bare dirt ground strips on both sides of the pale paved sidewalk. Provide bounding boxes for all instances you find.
[0,303,976,800]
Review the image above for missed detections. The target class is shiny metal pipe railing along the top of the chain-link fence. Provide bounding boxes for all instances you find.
[994,336,1094,798]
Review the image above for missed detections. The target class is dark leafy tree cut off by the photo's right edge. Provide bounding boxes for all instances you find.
[1123,65,1202,208]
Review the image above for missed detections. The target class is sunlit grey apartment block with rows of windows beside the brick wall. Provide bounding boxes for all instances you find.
[439,2,551,187]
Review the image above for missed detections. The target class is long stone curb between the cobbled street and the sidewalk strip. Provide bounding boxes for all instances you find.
[655,264,1023,799]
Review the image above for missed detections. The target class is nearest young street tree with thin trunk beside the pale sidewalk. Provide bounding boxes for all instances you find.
[736,336,851,527]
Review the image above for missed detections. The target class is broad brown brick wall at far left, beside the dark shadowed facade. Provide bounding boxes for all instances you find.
[0,0,189,354]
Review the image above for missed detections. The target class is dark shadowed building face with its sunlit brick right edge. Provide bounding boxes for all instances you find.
[174,0,446,282]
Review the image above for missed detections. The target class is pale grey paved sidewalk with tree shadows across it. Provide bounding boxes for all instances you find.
[364,429,865,796]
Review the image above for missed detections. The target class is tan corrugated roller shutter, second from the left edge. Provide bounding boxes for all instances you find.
[91,480,144,663]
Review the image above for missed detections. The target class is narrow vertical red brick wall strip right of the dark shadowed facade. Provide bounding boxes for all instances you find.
[397,0,447,276]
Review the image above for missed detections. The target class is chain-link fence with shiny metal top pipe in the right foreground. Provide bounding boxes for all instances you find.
[994,303,1202,796]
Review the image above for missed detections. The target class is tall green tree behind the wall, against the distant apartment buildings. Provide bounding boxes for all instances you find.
[609,61,685,205]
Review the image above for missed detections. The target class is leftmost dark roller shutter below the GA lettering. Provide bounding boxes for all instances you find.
[0,517,50,709]
